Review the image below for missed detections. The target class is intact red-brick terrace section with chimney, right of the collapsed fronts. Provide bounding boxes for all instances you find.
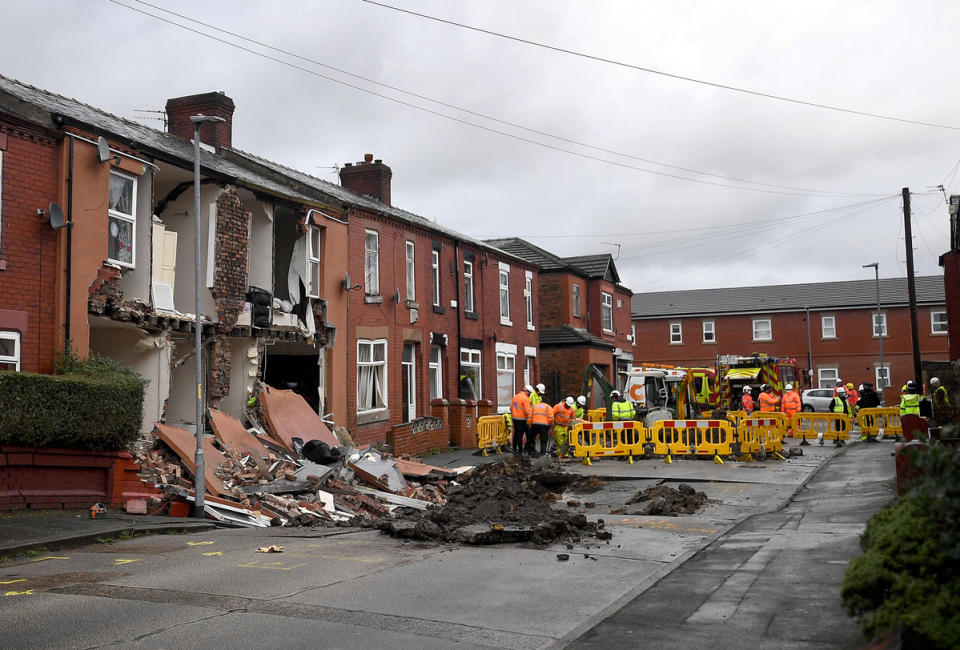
[340,154,539,444]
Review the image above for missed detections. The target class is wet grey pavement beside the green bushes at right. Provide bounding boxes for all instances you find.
[564,444,894,650]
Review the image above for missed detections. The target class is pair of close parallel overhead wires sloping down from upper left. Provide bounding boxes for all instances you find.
[110,0,879,196]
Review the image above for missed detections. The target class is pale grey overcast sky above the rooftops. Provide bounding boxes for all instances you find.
[0,0,960,293]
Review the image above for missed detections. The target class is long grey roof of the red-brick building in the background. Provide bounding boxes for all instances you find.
[630,275,946,319]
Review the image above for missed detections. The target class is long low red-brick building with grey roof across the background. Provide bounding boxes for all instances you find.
[633,276,948,404]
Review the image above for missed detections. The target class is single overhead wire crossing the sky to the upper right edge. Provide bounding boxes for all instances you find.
[362,0,960,131]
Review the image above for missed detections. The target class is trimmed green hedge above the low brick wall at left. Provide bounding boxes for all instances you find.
[0,357,146,450]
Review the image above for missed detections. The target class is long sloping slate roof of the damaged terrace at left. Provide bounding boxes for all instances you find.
[0,75,529,263]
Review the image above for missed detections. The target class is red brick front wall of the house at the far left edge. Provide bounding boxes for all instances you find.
[0,116,66,373]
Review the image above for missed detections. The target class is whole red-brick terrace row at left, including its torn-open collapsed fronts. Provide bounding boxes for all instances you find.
[0,77,538,451]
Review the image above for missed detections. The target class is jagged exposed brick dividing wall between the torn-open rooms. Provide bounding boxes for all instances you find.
[207,187,250,403]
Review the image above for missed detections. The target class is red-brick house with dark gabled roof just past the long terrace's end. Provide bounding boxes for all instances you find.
[488,238,633,402]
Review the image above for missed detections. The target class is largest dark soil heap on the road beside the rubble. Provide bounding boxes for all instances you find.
[377,458,597,544]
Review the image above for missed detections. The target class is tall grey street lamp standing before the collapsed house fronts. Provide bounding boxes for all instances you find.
[190,115,226,519]
